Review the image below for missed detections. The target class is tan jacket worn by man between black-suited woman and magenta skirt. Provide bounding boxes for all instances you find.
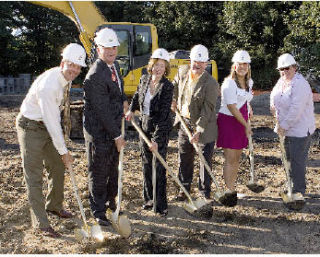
[172,65,219,144]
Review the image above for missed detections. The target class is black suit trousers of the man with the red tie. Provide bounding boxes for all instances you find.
[84,130,119,218]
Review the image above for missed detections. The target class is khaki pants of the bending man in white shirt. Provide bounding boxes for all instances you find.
[16,114,65,228]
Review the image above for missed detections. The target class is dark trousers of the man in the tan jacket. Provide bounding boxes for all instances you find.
[178,127,215,196]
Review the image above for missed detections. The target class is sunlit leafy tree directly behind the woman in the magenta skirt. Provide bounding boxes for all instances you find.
[218,1,301,89]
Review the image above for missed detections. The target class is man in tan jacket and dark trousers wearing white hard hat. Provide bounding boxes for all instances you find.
[172,45,219,201]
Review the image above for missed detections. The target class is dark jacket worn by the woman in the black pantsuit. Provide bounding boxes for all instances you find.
[130,74,173,143]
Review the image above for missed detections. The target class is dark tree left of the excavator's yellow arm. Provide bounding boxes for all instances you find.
[1,2,79,74]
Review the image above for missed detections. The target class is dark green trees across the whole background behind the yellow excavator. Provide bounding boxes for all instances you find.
[0,1,320,89]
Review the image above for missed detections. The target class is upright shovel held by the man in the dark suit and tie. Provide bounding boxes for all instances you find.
[110,118,131,238]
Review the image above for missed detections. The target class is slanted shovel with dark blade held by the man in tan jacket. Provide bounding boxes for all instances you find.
[176,110,237,207]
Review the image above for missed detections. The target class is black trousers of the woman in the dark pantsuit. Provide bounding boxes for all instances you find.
[140,116,169,212]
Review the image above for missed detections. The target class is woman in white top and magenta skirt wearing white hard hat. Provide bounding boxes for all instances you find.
[217,50,253,206]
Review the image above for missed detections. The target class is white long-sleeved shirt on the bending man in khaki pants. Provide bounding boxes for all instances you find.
[20,67,69,155]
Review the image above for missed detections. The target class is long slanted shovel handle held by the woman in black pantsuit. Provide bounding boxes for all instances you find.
[131,118,197,209]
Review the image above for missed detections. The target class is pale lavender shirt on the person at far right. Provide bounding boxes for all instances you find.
[270,73,316,137]
